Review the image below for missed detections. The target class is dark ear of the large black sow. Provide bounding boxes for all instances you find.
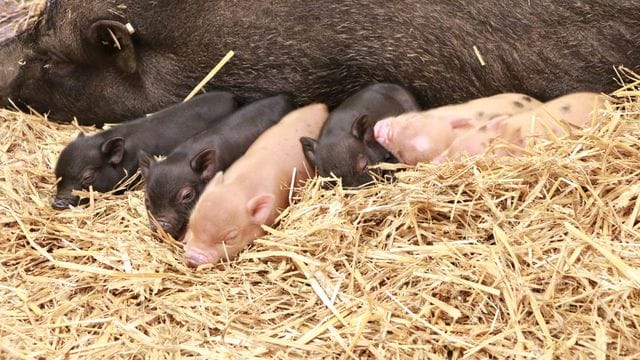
[88,20,138,74]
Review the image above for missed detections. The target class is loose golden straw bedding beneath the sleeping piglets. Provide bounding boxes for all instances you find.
[0,3,640,359]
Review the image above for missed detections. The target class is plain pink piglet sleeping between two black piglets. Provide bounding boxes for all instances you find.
[185,104,328,266]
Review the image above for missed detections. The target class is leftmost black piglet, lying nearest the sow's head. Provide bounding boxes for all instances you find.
[51,91,236,210]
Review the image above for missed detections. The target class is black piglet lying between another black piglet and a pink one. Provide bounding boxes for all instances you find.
[138,95,293,239]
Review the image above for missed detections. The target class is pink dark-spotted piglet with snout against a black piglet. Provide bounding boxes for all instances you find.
[374,93,542,165]
